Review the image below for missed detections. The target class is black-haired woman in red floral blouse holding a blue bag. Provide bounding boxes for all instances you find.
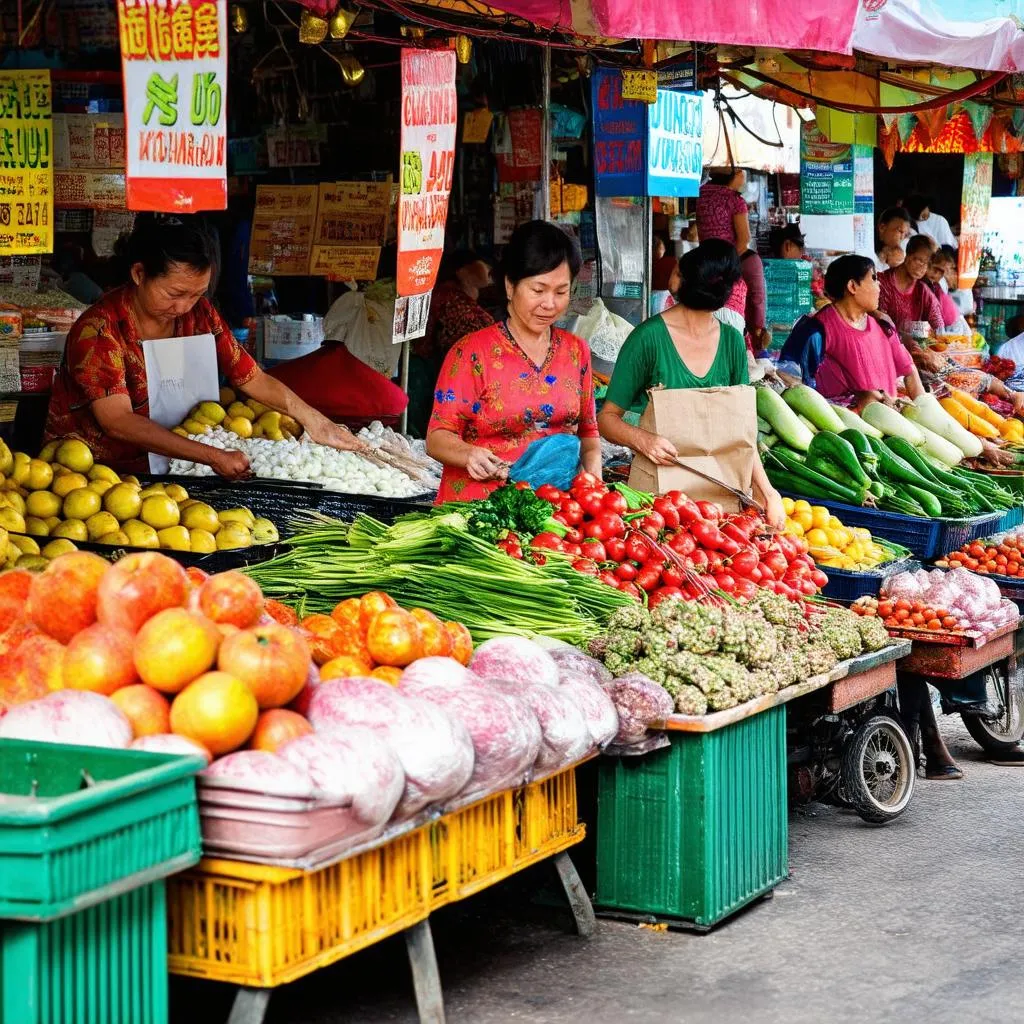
[427,220,601,504]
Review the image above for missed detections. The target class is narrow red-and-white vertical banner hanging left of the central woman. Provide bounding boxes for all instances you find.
[397,49,458,309]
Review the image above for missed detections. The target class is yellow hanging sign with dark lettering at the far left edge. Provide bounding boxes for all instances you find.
[0,71,53,256]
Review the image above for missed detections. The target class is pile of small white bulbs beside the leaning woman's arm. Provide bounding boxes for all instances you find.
[170,427,426,498]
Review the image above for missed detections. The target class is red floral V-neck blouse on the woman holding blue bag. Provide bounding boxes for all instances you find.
[427,324,598,504]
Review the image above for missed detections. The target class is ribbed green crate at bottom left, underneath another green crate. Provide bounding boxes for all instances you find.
[0,882,168,1024]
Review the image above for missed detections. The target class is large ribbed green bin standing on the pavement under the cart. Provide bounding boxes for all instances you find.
[595,707,788,928]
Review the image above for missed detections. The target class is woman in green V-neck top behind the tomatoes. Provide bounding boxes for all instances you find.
[597,239,785,528]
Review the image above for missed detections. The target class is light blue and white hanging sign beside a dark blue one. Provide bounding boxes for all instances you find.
[646,89,703,198]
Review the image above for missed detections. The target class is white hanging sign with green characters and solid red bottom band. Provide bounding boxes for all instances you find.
[118,0,227,213]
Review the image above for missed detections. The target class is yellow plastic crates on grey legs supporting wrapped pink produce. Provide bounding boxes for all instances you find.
[166,765,594,1024]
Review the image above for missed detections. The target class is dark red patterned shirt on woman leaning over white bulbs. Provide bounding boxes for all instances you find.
[45,285,259,472]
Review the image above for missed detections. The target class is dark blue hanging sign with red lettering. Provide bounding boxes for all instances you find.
[590,68,647,196]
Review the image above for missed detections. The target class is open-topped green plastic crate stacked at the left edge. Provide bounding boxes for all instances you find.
[0,739,204,921]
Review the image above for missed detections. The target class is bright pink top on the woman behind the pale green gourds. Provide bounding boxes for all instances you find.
[814,306,913,398]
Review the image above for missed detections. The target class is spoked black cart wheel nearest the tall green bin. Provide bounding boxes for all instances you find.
[842,715,916,824]
